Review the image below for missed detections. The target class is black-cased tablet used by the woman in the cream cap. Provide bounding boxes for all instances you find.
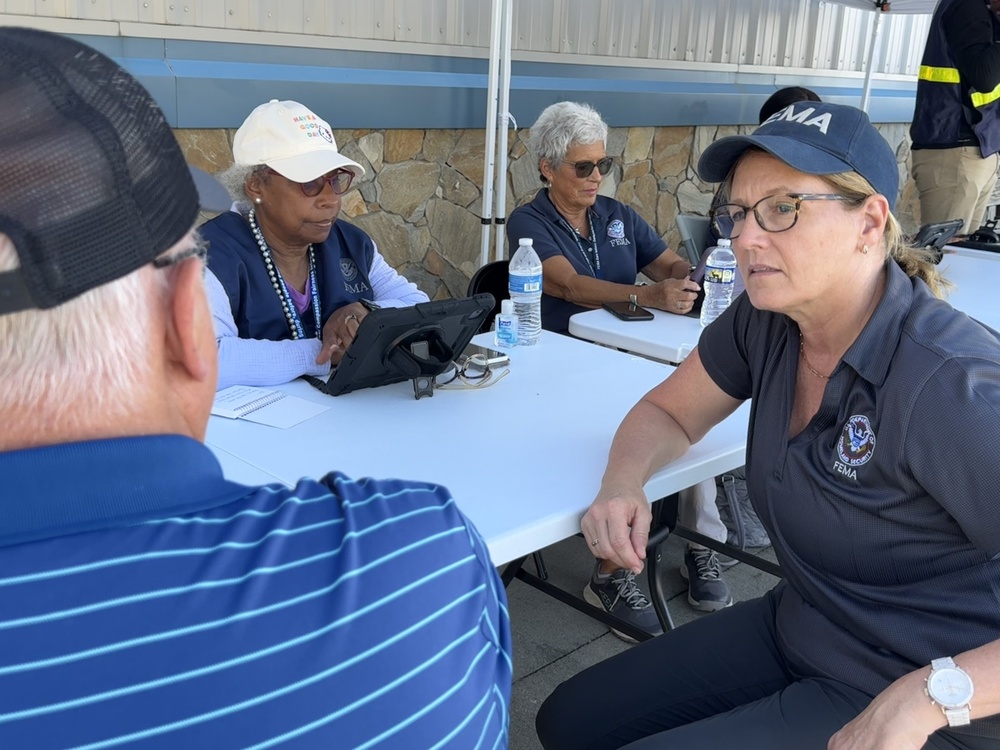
[325,294,493,396]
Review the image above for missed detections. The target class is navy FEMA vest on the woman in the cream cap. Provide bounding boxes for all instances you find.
[198,211,375,341]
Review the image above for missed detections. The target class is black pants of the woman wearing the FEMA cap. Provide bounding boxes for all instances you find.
[535,594,996,750]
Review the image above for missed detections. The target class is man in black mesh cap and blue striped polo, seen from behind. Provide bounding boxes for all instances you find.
[0,28,511,748]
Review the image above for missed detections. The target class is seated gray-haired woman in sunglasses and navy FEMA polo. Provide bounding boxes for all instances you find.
[507,102,733,640]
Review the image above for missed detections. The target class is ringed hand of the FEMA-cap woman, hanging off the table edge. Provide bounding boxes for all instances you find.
[580,487,653,573]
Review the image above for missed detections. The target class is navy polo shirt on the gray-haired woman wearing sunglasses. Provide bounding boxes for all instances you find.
[507,188,667,333]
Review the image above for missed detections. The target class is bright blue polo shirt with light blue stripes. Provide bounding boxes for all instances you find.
[0,436,511,750]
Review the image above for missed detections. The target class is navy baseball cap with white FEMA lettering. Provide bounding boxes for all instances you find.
[698,102,899,210]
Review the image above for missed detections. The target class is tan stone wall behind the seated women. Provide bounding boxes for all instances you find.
[177,125,918,299]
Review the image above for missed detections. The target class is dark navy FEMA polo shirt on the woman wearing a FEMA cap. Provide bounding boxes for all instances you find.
[698,262,1000,738]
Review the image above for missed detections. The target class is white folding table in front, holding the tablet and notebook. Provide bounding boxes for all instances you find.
[206,332,749,565]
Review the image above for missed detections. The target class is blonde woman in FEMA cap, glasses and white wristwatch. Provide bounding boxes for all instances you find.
[537,102,1000,750]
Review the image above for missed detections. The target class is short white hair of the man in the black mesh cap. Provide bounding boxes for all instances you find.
[0,232,195,430]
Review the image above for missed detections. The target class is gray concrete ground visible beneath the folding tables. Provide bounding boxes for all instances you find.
[507,537,777,750]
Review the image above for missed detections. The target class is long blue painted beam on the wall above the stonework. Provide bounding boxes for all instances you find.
[66,36,916,129]
